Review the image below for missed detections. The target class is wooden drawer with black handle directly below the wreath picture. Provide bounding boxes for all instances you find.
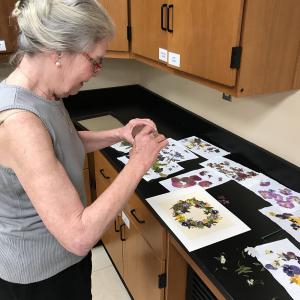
[125,194,167,259]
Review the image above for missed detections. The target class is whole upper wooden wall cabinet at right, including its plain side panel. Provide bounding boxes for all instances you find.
[131,0,300,96]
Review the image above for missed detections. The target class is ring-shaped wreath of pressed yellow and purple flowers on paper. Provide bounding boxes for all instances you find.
[171,197,222,229]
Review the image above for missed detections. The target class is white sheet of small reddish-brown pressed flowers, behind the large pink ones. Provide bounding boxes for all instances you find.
[200,156,259,188]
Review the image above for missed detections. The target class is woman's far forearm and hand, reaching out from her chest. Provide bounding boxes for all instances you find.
[78,119,156,153]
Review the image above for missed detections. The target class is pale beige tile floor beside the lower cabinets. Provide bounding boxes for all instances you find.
[92,246,131,300]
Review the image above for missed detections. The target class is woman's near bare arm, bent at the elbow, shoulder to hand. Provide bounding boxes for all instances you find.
[1,112,167,255]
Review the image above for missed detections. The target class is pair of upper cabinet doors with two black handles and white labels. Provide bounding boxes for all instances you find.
[131,0,243,86]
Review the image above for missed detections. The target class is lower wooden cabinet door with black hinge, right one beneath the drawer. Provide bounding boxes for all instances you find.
[123,218,165,300]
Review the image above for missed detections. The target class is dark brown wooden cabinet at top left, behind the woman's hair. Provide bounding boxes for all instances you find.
[0,0,17,54]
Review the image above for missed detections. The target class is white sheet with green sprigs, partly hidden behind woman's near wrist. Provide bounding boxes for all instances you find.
[118,155,183,181]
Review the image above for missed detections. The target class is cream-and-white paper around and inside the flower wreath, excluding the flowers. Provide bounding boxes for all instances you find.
[146,187,250,251]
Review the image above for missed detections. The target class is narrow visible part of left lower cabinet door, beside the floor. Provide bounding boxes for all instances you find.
[102,216,123,276]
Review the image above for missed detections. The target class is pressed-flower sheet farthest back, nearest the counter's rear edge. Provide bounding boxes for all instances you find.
[179,136,230,159]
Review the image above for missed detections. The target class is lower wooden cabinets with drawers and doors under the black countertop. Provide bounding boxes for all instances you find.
[94,152,167,300]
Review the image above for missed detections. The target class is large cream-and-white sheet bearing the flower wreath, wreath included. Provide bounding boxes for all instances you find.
[146,186,250,251]
